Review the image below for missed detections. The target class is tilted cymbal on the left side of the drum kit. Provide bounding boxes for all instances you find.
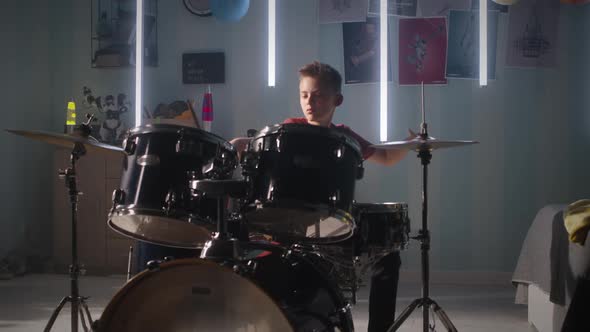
[6,129,124,153]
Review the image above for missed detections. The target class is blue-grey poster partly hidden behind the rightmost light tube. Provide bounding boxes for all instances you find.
[447,10,499,80]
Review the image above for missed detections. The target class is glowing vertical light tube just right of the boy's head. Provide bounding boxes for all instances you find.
[379,0,388,142]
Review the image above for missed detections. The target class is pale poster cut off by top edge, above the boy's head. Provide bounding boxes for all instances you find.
[319,0,368,24]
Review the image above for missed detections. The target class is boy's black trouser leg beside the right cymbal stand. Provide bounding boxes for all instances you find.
[368,251,401,332]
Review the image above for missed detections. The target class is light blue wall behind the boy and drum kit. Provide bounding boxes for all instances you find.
[1,0,590,271]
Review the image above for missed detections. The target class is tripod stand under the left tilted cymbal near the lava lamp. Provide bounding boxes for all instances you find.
[43,117,92,332]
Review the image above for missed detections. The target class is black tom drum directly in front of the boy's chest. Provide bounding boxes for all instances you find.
[242,124,363,243]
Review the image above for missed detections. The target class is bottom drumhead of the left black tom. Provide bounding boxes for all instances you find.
[108,209,215,249]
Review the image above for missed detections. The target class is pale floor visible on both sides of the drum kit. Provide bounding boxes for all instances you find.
[0,274,534,332]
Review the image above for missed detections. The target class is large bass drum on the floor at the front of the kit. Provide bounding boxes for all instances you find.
[94,247,354,332]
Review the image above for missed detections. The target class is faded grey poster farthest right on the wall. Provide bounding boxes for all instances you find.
[506,0,559,67]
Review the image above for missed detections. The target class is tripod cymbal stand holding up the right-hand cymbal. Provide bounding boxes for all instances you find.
[387,84,457,332]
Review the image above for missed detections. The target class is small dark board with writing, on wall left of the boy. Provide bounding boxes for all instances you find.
[182,52,225,84]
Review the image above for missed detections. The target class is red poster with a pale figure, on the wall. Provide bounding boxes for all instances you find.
[398,17,447,85]
